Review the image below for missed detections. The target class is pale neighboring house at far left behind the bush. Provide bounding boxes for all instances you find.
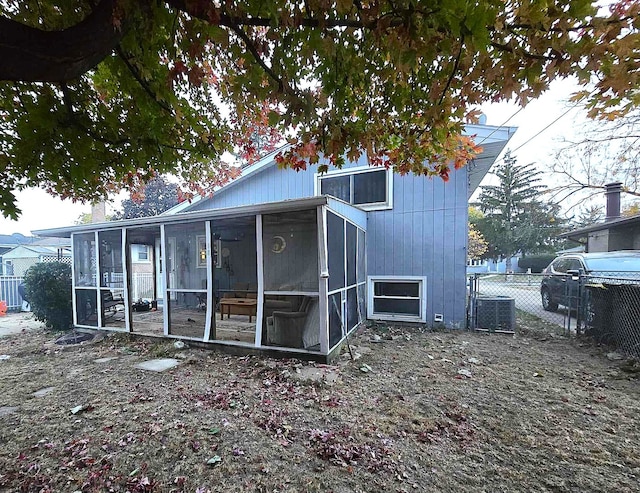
[2,238,71,277]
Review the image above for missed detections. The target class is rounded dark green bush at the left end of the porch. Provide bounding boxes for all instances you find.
[24,262,73,330]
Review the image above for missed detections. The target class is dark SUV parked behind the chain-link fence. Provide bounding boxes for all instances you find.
[540,250,640,311]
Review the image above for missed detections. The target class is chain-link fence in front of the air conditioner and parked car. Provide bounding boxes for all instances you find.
[467,272,640,358]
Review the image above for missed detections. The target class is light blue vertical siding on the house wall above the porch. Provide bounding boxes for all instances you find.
[190,154,468,327]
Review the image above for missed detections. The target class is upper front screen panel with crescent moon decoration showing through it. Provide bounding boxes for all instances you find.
[262,209,319,293]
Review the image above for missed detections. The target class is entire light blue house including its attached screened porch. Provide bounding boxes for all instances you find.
[33,125,515,359]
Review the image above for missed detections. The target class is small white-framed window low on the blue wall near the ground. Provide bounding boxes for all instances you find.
[368,276,426,322]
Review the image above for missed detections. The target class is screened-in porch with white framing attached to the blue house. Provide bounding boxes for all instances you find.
[36,196,367,360]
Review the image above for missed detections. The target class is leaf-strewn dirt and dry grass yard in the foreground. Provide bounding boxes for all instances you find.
[0,319,640,493]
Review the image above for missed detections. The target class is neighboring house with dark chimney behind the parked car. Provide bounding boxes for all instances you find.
[560,183,640,253]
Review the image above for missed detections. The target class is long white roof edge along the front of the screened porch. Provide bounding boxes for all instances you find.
[33,195,332,238]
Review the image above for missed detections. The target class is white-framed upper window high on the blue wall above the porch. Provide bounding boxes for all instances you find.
[316,167,393,210]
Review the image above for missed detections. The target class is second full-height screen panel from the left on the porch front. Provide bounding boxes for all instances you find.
[98,230,125,328]
